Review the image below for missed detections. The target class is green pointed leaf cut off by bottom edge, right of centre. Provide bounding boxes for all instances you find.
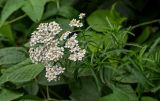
[98,89,131,101]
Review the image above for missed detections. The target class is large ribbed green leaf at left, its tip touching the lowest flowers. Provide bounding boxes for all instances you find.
[0,64,44,84]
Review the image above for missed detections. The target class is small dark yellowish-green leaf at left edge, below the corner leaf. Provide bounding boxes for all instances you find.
[0,25,15,44]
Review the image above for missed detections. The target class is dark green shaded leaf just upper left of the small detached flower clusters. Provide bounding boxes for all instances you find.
[58,6,78,18]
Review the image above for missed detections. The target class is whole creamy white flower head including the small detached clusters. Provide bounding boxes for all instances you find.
[29,13,86,81]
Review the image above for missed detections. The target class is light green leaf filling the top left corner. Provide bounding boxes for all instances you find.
[1,0,24,25]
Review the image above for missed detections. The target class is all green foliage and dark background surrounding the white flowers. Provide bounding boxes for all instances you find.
[0,0,160,101]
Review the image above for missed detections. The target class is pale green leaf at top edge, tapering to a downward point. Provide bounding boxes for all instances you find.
[22,0,47,22]
